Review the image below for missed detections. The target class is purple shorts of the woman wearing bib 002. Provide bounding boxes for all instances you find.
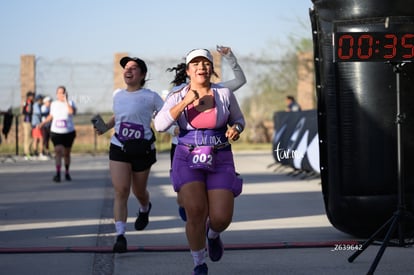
[170,145,243,197]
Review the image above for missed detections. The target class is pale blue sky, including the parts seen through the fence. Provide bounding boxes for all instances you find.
[0,0,312,111]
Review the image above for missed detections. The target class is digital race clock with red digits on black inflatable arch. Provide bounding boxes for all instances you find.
[333,31,414,62]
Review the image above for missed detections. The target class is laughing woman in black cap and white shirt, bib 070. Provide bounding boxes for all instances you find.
[96,56,164,253]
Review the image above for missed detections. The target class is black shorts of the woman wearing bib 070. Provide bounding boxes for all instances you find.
[109,143,157,172]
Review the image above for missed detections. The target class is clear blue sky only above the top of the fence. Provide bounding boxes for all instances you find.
[0,0,312,64]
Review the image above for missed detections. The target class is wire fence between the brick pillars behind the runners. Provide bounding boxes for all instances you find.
[0,54,310,157]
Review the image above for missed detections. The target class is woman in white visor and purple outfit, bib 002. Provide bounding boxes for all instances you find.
[154,49,245,274]
